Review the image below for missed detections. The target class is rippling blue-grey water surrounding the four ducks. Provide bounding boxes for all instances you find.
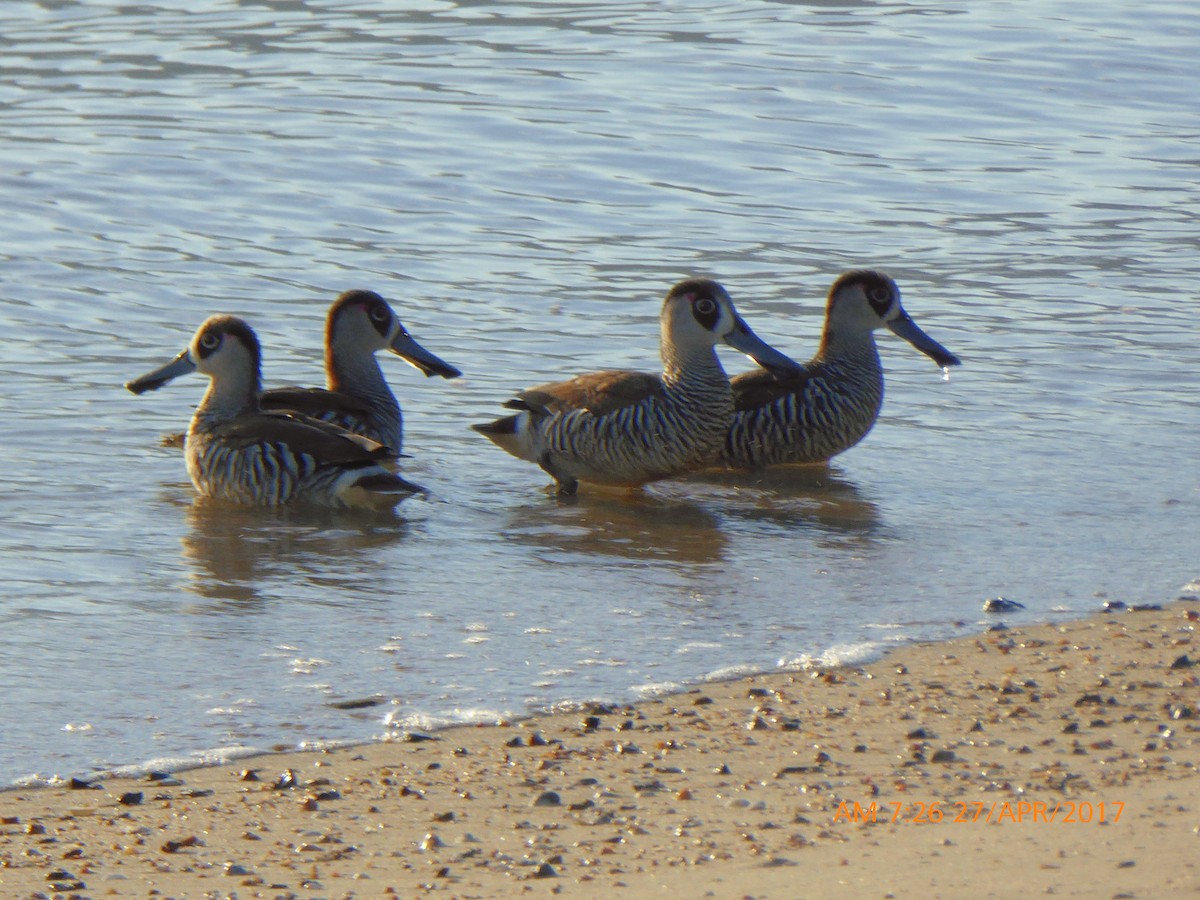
[0,0,1200,784]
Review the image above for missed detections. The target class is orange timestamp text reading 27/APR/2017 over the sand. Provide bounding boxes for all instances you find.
[833,800,1124,824]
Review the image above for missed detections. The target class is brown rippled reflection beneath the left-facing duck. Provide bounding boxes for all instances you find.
[180,497,408,604]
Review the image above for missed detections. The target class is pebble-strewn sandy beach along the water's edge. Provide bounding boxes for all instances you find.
[0,601,1200,899]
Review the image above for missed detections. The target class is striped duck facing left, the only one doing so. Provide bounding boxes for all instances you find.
[125,314,424,510]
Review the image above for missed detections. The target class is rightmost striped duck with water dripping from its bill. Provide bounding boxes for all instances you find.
[719,269,961,470]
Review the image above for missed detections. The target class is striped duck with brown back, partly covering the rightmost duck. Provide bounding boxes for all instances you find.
[472,277,799,497]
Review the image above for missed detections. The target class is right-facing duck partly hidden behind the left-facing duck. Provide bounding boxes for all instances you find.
[262,290,462,456]
